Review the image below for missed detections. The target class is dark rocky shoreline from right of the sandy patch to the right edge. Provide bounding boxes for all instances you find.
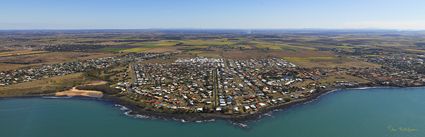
[97,84,425,124]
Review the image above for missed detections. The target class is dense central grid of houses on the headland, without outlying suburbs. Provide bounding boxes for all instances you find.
[128,57,298,114]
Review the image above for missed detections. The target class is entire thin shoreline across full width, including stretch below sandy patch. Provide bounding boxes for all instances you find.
[0,84,424,128]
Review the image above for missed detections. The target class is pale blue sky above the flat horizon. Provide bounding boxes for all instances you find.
[0,0,425,29]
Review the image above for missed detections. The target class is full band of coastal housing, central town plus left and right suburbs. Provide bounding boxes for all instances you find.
[0,50,425,116]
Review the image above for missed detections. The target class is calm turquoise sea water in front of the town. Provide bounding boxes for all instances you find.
[0,88,425,137]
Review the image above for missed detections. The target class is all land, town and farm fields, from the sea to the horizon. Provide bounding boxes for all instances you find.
[0,32,425,120]
